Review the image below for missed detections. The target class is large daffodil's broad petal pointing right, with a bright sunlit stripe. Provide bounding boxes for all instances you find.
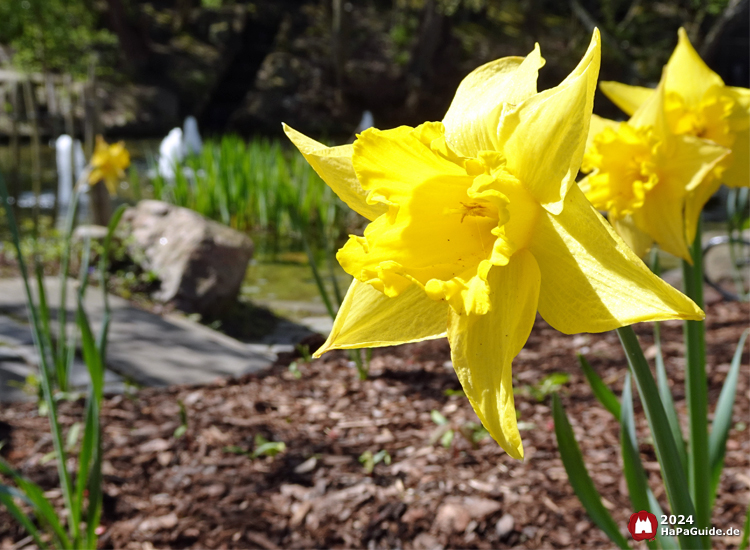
[529,187,704,334]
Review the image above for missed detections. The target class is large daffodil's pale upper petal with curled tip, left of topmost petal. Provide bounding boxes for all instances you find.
[443,44,544,157]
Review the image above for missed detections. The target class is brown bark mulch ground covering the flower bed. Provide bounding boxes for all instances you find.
[0,302,750,549]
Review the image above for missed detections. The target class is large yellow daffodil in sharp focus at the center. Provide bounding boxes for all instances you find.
[284,32,703,459]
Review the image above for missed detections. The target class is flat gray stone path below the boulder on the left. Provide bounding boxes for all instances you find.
[0,277,284,402]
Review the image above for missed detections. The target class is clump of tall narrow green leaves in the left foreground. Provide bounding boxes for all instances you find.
[0,172,124,549]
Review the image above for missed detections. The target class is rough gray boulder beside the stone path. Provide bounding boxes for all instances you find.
[118,200,253,316]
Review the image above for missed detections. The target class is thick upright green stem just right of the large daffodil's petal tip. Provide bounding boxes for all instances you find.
[682,217,711,528]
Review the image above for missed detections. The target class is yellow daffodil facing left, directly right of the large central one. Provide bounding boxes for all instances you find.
[580,70,730,263]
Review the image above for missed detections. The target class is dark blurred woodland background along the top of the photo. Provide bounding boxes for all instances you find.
[0,0,750,140]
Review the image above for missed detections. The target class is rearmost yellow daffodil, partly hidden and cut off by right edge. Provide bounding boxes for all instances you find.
[600,28,750,191]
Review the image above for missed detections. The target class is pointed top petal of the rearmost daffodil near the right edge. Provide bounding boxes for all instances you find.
[666,27,724,110]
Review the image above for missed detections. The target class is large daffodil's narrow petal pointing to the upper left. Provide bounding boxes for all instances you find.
[283,124,387,220]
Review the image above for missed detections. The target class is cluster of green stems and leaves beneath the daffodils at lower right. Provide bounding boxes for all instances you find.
[553,223,750,549]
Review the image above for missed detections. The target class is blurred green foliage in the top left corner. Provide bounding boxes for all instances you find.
[0,0,117,76]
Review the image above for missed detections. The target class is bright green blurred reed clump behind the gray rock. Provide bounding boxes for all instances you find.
[152,135,347,254]
